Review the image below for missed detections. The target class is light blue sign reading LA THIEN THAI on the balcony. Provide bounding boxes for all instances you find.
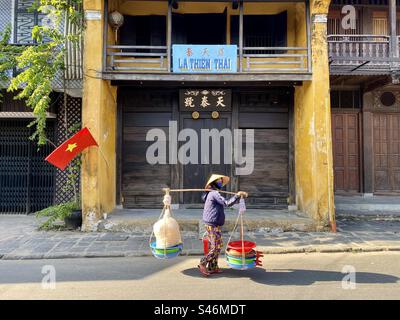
[172,44,237,73]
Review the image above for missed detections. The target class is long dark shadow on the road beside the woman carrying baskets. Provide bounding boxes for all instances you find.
[182,268,399,286]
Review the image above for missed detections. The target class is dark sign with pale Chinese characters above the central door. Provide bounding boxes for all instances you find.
[179,89,232,112]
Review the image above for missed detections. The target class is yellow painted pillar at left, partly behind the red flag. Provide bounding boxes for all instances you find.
[81,0,116,231]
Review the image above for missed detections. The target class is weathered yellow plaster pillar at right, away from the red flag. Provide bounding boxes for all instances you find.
[295,0,334,228]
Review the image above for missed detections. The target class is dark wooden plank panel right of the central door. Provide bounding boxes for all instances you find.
[237,88,293,209]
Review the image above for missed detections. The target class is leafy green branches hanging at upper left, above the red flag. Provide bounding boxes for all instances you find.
[0,0,84,145]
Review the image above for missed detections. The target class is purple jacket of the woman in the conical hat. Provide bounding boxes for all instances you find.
[202,190,240,227]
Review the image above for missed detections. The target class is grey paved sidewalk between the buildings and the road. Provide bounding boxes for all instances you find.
[0,215,400,260]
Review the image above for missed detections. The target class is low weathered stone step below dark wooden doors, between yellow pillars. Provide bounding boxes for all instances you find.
[99,209,322,233]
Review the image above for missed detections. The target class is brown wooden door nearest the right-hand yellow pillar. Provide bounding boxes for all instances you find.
[332,111,360,193]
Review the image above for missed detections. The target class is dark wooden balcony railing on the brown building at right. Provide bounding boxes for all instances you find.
[328,35,400,75]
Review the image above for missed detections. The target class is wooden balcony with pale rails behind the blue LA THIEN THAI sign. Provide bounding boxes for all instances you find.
[101,0,312,84]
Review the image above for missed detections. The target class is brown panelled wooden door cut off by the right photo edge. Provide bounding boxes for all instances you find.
[373,113,400,193]
